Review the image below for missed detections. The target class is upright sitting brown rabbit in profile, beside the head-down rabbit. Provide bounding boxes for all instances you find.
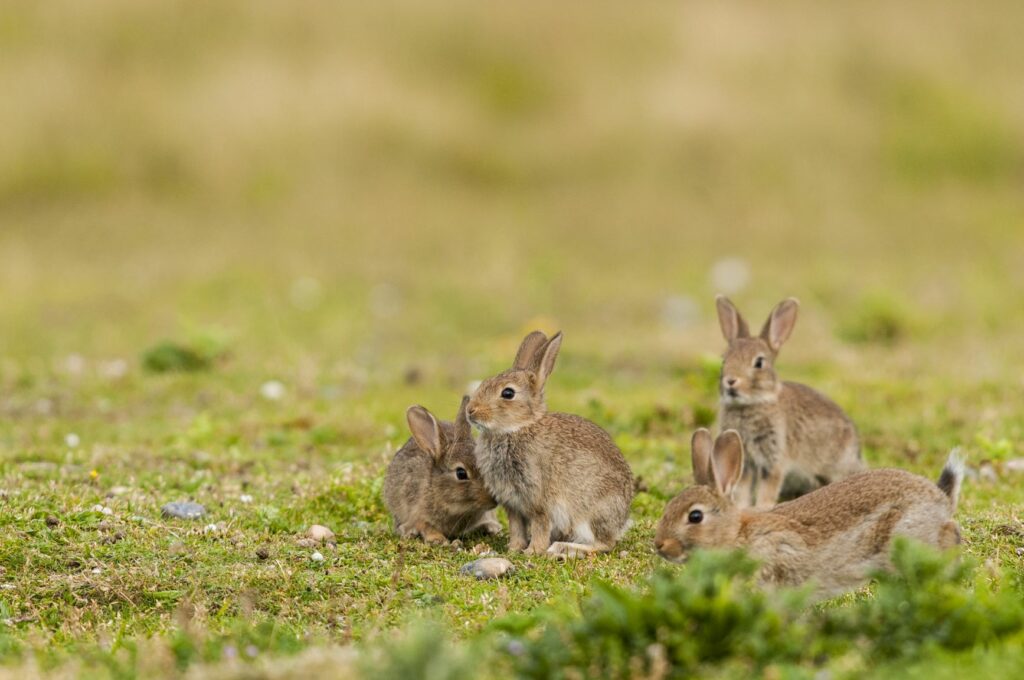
[467,331,633,558]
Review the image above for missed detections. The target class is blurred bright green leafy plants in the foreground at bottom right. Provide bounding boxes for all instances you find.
[497,541,1024,678]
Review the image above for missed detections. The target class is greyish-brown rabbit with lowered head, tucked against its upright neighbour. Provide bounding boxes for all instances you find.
[384,396,502,543]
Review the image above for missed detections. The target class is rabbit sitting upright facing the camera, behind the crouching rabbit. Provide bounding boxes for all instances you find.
[717,295,864,507]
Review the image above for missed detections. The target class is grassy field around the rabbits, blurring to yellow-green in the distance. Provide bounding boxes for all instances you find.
[0,0,1024,677]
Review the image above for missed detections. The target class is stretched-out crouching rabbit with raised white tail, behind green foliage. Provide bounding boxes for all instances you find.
[654,429,964,598]
